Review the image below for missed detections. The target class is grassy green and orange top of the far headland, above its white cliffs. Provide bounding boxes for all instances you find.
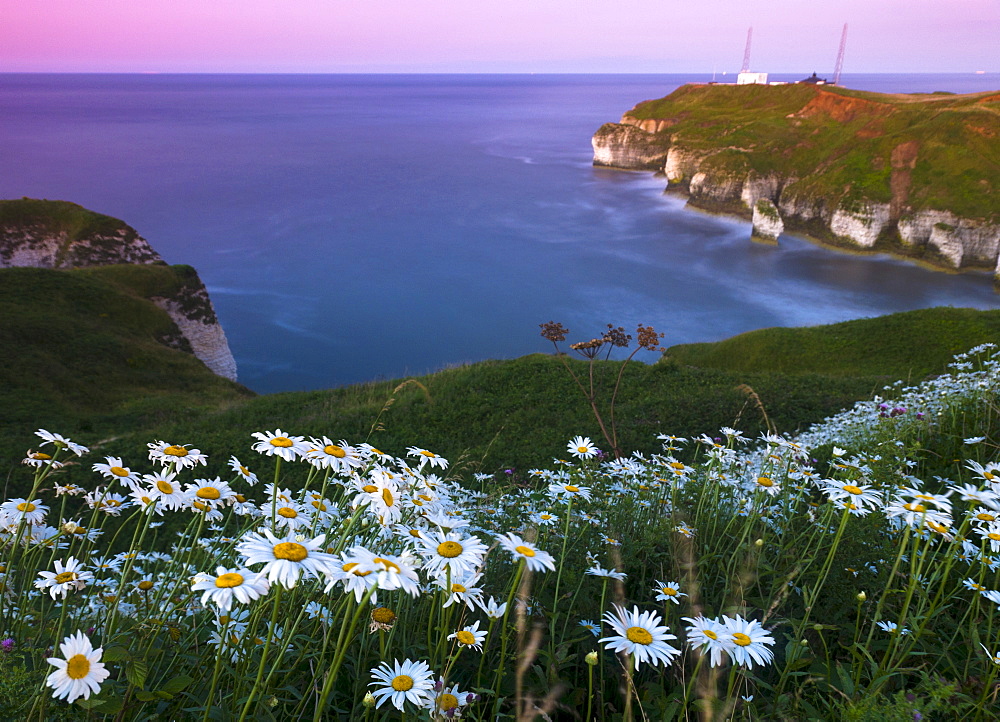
[623,84,1000,220]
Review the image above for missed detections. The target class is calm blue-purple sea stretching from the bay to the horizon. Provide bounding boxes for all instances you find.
[0,73,1000,392]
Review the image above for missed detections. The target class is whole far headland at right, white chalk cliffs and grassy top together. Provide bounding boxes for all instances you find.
[592,84,1000,280]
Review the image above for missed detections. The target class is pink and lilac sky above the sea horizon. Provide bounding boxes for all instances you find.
[0,0,1000,75]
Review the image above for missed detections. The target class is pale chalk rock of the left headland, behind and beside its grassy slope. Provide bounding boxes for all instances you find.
[0,198,237,381]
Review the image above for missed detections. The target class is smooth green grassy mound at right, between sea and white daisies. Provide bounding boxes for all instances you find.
[666,308,1000,381]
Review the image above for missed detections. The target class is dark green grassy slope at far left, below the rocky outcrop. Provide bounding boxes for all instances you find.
[0,265,252,461]
